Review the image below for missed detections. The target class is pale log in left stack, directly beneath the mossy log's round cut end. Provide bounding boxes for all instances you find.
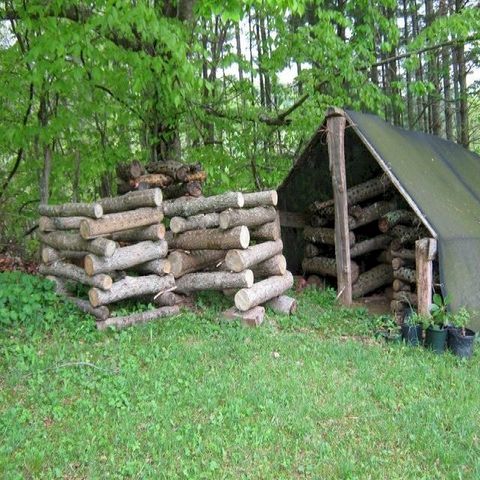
[85,240,168,275]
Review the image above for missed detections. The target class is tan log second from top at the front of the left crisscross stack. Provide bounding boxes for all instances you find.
[80,208,163,239]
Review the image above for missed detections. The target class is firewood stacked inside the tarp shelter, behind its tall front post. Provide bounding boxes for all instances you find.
[302,176,427,309]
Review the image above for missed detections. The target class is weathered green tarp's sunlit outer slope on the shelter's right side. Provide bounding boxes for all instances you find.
[345,110,480,330]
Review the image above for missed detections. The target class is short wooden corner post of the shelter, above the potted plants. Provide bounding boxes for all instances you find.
[415,238,437,315]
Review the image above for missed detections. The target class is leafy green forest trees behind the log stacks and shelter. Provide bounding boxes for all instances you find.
[0,0,480,254]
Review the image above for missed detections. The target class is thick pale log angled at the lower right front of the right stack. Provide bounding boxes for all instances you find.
[235,271,293,312]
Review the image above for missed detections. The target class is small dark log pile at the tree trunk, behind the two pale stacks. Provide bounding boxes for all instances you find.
[116,161,207,199]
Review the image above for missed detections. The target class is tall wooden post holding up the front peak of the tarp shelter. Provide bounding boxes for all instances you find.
[327,109,352,306]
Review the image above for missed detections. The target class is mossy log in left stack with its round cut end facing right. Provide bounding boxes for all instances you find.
[38,232,117,257]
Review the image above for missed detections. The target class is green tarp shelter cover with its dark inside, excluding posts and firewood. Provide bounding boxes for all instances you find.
[278,110,480,327]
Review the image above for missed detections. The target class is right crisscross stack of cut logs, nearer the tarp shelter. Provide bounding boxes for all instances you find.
[160,191,296,325]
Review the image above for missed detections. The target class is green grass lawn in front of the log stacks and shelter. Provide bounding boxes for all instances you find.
[0,278,480,479]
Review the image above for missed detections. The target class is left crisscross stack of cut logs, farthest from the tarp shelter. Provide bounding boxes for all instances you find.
[35,189,178,329]
